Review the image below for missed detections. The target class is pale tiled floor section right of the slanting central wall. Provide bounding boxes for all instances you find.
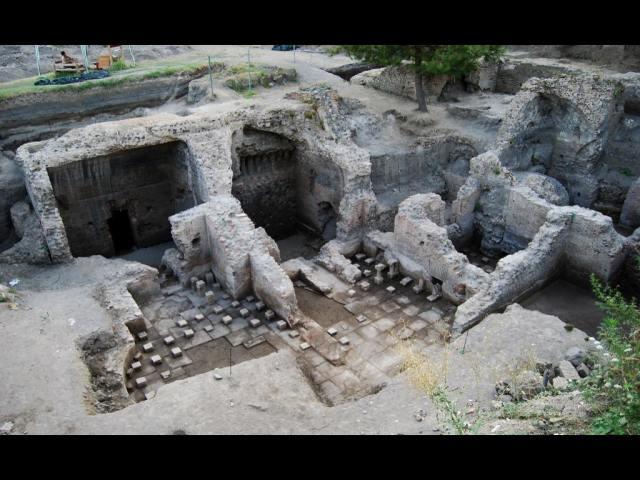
[298,254,454,405]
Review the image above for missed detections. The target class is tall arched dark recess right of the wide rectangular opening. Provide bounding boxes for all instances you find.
[232,127,343,259]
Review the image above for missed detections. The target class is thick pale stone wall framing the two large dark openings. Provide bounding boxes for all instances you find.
[12,91,375,262]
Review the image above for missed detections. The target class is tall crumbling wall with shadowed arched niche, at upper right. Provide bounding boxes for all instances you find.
[496,75,624,207]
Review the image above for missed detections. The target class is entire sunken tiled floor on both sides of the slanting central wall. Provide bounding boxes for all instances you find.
[125,251,455,405]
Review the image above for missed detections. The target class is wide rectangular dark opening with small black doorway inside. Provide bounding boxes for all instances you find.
[47,141,196,257]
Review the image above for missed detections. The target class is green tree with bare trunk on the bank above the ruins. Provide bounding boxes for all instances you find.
[340,45,504,112]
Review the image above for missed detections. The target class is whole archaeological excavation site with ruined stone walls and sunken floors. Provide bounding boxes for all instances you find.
[0,45,640,435]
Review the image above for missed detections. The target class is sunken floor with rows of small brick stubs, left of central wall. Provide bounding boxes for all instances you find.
[126,281,283,401]
